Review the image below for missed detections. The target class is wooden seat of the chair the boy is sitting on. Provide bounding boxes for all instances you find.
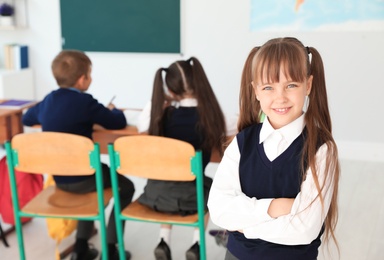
[21,186,112,217]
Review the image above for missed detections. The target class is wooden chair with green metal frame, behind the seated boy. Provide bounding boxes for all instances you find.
[5,132,112,260]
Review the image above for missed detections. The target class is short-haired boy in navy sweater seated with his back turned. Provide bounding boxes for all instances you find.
[23,50,134,260]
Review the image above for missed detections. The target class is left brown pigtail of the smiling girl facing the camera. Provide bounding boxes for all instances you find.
[237,47,261,131]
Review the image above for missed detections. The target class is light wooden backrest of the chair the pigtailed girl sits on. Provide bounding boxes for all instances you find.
[109,135,201,181]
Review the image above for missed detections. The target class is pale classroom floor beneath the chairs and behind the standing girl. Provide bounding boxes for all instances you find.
[0,158,384,260]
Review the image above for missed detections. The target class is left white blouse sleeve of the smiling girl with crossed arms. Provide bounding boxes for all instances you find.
[208,137,272,231]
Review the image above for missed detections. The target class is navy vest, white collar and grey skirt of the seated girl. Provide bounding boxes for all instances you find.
[139,98,212,215]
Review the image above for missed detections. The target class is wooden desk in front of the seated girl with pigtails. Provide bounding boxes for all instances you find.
[92,125,221,163]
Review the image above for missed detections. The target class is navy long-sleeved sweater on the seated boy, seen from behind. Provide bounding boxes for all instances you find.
[22,88,127,183]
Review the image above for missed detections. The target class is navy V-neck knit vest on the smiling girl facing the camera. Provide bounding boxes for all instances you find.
[227,124,322,260]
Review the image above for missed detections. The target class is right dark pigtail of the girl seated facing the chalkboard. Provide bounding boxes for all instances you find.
[187,57,226,155]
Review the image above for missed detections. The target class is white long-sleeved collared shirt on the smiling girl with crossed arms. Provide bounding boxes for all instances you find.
[208,114,333,245]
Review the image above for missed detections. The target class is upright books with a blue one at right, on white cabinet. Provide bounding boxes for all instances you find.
[4,44,29,70]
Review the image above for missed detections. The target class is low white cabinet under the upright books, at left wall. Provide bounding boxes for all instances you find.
[0,68,35,100]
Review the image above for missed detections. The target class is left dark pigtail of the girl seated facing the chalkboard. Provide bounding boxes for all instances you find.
[148,68,166,135]
